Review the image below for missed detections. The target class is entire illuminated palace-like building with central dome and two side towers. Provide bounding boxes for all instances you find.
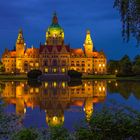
[2,14,107,74]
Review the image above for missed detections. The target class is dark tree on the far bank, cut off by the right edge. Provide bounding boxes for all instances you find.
[132,55,140,75]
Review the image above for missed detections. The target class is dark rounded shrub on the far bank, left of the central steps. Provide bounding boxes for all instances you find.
[27,70,42,79]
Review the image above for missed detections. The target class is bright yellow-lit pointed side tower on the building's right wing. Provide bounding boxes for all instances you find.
[84,30,93,57]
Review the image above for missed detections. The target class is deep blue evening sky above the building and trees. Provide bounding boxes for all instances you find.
[0,0,140,59]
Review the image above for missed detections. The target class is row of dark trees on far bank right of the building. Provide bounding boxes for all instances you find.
[107,55,140,76]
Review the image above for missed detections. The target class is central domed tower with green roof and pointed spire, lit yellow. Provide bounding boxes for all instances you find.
[46,13,64,46]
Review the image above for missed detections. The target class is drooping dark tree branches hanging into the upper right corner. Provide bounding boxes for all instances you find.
[114,0,140,45]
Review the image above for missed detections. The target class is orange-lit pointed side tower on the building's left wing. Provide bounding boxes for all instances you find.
[16,29,25,57]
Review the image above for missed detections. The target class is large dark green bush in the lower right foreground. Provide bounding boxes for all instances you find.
[76,102,140,140]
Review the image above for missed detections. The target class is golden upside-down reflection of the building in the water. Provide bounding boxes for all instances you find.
[1,80,107,126]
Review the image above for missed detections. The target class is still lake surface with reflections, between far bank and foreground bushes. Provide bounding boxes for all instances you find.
[0,80,140,130]
